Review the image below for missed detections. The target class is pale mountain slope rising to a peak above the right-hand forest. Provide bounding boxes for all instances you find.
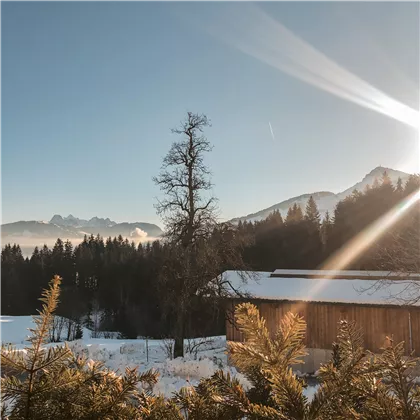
[231,166,410,223]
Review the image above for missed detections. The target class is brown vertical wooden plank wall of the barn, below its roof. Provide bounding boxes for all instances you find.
[226,300,420,356]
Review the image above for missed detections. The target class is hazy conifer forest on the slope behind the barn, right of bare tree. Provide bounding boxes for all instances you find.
[238,172,420,271]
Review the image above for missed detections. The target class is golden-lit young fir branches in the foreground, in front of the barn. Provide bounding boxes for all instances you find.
[175,303,420,420]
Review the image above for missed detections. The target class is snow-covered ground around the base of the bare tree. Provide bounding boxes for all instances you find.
[0,316,315,397]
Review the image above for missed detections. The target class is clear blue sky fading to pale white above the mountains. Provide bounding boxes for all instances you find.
[1,1,420,224]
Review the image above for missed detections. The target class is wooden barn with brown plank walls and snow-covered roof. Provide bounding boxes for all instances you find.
[223,270,420,371]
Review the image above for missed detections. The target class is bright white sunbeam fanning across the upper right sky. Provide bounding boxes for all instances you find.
[202,3,420,128]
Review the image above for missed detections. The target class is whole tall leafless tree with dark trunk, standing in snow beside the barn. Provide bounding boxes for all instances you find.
[154,112,248,357]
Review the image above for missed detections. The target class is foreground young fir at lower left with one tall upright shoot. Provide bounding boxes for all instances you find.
[0,276,156,420]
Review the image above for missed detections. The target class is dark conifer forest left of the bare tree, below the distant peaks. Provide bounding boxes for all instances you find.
[0,236,217,337]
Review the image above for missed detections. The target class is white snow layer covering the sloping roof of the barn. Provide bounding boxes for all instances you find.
[223,270,420,306]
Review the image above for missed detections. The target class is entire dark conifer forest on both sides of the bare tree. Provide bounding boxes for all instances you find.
[0,173,420,337]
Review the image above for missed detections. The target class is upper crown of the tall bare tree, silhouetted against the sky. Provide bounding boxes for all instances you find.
[153,112,217,248]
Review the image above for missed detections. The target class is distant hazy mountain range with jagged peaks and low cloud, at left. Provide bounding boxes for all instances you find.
[1,214,163,243]
